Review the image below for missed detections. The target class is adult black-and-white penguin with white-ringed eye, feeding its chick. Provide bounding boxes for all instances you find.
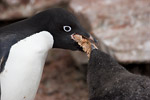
[0,8,96,100]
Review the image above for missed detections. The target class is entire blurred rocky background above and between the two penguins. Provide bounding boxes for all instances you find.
[0,0,150,100]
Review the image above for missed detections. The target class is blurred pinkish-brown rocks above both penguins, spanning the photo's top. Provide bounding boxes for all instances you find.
[0,0,150,63]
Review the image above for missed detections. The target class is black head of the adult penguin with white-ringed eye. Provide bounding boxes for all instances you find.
[48,8,95,51]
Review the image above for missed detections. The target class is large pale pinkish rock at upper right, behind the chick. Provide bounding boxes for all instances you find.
[70,0,150,63]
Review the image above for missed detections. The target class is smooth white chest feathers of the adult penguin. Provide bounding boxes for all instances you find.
[0,31,54,100]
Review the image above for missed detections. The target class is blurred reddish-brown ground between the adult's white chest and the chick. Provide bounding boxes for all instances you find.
[35,50,88,100]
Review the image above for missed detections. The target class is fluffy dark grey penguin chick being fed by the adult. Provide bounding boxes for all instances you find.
[87,49,150,100]
